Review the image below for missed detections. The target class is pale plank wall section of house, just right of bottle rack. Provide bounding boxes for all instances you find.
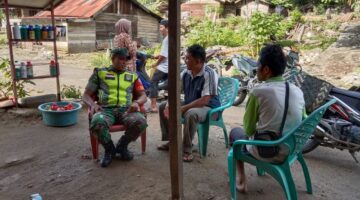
[68,21,96,53]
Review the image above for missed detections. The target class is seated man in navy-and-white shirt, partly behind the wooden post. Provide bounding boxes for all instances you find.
[158,45,220,162]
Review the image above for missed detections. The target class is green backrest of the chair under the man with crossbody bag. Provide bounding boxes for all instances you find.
[284,99,336,157]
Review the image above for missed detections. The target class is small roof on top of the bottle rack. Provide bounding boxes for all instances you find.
[0,0,64,9]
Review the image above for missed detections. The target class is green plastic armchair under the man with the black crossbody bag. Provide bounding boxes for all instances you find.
[228,100,336,200]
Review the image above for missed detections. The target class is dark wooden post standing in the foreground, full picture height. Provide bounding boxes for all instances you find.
[168,0,183,199]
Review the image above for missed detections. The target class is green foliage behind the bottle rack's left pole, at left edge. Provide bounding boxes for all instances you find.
[0,58,35,98]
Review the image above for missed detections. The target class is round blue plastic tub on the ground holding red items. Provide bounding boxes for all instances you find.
[38,101,82,126]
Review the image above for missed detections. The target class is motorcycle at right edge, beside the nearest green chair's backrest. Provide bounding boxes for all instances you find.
[303,88,360,163]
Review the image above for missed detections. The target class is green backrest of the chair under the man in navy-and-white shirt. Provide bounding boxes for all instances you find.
[218,77,239,106]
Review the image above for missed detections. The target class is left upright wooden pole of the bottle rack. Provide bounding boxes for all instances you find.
[4,0,18,107]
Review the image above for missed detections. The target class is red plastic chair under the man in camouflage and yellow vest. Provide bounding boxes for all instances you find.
[88,98,146,159]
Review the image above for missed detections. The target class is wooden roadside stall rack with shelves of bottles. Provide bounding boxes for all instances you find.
[0,0,64,106]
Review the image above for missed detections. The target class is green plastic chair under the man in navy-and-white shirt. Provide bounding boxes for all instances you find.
[197,77,239,157]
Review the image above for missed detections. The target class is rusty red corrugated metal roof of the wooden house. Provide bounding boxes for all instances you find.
[33,0,161,19]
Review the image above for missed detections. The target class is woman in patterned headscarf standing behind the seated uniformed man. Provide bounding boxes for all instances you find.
[114,19,136,71]
